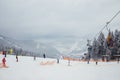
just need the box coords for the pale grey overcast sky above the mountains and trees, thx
[0,0,120,39]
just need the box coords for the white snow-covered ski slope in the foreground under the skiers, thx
[0,55,120,80]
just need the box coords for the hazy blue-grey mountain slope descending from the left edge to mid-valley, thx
[0,35,60,58]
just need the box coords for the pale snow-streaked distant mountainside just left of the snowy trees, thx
[53,38,87,54]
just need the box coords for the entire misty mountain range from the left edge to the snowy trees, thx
[0,35,92,58]
